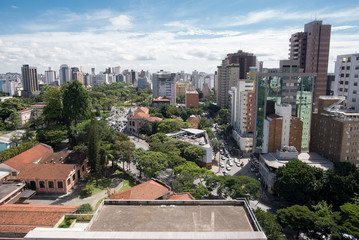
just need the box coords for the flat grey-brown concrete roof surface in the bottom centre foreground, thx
[87,200,256,232]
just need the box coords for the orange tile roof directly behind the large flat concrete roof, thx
[111,180,171,200]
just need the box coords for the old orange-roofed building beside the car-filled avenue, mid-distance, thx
[127,107,162,134]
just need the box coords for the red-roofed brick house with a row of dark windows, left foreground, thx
[17,153,87,193]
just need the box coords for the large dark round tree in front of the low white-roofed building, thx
[274,159,324,206]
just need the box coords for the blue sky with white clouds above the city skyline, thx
[0,0,359,73]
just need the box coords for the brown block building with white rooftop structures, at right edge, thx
[310,96,359,167]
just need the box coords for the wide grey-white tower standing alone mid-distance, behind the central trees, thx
[152,70,176,105]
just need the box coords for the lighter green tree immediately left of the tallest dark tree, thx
[43,88,63,123]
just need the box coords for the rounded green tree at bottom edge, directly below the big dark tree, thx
[277,205,316,239]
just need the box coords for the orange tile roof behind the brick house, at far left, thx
[3,143,53,171]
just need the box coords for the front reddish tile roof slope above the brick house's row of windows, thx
[17,163,75,180]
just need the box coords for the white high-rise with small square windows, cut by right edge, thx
[333,54,359,112]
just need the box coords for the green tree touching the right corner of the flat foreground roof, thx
[254,208,285,240]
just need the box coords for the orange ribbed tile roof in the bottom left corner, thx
[0,204,78,235]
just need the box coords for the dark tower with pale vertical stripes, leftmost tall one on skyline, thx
[21,65,39,97]
